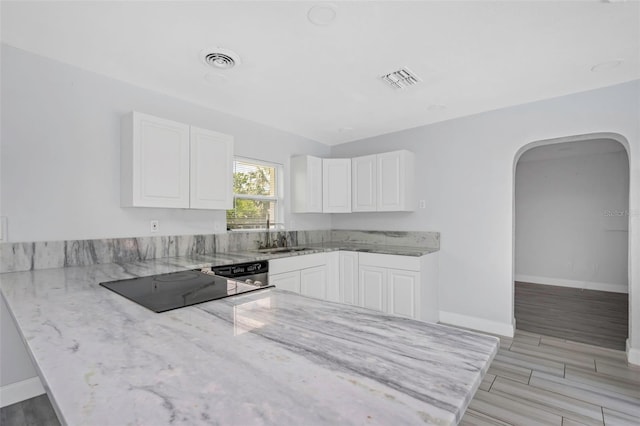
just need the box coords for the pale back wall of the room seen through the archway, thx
[515,145,629,293]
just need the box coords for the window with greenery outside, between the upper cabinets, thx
[227,158,282,229]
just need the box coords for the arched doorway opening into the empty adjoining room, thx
[514,134,630,350]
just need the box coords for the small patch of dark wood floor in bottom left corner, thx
[0,394,60,426]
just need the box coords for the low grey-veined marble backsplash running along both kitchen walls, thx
[0,230,440,273]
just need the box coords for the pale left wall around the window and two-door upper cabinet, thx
[0,45,331,241]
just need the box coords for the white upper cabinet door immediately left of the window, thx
[190,127,233,210]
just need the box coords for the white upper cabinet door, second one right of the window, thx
[322,158,351,213]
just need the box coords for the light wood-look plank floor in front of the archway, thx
[461,330,640,426]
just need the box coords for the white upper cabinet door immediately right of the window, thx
[290,155,322,213]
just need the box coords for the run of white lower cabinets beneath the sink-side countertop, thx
[269,251,438,322]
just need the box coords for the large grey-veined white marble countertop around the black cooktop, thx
[0,254,498,425]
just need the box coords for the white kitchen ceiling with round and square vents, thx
[1,0,640,145]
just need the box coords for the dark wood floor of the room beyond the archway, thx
[515,282,629,350]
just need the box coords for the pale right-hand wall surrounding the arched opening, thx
[332,81,640,363]
